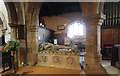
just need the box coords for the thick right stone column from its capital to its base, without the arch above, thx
[84,14,105,73]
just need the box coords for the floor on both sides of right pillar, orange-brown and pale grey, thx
[0,61,120,74]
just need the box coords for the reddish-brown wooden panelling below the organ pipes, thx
[101,29,120,49]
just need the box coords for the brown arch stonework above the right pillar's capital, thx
[80,2,104,17]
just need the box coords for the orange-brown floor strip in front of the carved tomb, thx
[17,66,84,74]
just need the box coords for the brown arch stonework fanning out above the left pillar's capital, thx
[25,2,42,25]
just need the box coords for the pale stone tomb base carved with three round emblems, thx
[37,53,81,70]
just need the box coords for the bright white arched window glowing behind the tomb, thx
[67,21,85,38]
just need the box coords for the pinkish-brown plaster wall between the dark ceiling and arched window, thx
[43,12,82,31]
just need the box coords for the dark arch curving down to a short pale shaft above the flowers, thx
[5,2,18,38]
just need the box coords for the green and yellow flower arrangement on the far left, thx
[3,38,21,52]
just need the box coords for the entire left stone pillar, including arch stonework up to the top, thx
[24,2,42,65]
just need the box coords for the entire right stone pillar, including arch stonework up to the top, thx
[80,2,106,74]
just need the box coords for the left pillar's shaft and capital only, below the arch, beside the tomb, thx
[27,25,38,65]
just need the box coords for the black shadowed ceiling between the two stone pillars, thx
[40,2,81,17]
